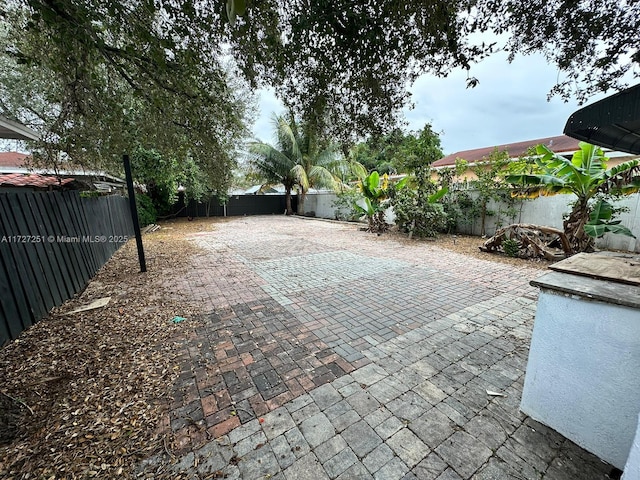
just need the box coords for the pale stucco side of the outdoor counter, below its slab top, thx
[520,289,640,469]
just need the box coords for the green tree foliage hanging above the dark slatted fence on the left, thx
[0,0,251,193]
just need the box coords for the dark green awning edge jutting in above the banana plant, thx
[564,84,640,154]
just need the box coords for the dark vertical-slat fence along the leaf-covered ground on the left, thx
[0,192,133,346]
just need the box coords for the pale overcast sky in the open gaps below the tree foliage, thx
[254,50,604,154]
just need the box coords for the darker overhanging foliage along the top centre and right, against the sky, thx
[228,0,640,139]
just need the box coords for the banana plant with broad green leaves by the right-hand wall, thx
[505,142,640,253]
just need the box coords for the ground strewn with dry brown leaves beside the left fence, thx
[0,222,212,479]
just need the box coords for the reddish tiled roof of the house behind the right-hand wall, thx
[431,135,580,167]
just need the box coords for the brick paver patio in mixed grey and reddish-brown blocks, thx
[139,216,615,480]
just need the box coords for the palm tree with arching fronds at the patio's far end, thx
[249,115,341,215]
